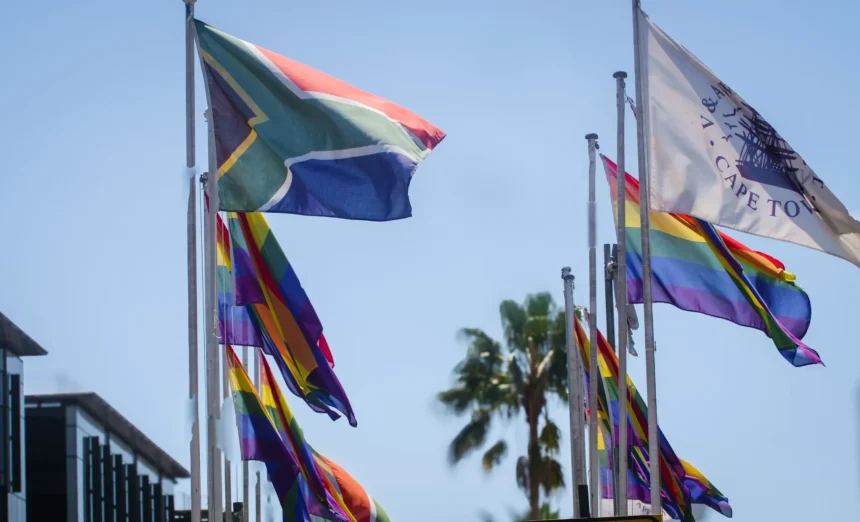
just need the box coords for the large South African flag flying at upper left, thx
[195,20,445,221]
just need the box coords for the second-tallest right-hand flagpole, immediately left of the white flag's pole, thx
[612,71,628,516]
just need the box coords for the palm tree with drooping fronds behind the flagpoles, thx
[438,293,567,520]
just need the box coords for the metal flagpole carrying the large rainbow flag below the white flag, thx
[585,134,600,515]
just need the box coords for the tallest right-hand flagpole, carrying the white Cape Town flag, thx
[633,0,662,513]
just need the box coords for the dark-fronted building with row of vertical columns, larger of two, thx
[25,393,189,522]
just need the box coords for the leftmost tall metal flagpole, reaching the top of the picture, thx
[184,0,202,522]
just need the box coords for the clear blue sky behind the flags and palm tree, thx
[0,0,860,522]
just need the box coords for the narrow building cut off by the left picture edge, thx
[0,312,48,522]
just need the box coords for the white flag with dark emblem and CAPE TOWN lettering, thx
[638,11,860,266]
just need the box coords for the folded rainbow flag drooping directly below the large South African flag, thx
[228,213,357,426]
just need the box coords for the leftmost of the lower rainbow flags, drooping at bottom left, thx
[227,346,349,522]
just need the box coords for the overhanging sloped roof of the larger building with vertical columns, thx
[24,392,190,479]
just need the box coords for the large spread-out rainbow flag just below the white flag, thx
[601,155,821,366]
